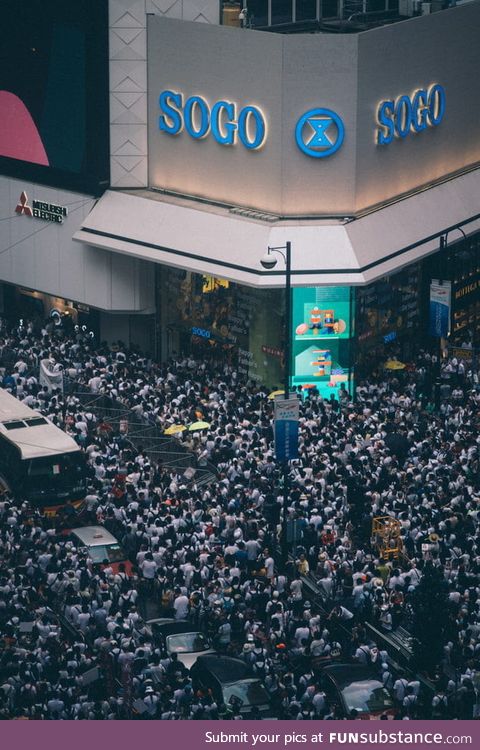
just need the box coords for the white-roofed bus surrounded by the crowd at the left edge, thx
[0,388,87,516]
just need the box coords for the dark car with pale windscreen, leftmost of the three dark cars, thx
[140,617,217,669]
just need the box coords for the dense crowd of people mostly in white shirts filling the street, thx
[0,312,480,719]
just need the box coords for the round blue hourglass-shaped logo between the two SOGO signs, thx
[295,108,345,159]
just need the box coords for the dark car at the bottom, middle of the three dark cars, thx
[190,654,272,718]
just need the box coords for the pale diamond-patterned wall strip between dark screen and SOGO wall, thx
[109,0,220,188]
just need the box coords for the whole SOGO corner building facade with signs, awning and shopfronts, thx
[0,0,480,395]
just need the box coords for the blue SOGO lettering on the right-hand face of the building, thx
[376,83,445,146]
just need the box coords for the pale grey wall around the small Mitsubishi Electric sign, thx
[0,177,154,312]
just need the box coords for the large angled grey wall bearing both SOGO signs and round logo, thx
[148,11,480,218]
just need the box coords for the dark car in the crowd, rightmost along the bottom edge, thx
[319,664,397,719]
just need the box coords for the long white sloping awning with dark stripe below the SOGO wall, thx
[74,169,480,287]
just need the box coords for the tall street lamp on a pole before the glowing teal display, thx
[260,242,292,568]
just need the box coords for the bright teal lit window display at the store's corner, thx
[292,287,352,399]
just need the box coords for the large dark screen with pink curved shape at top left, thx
[0,0,109,193]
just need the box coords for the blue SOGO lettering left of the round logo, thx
[158,89,267,150]
